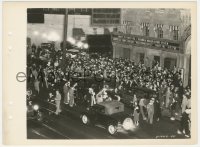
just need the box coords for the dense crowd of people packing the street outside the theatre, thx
[27,43,191,138]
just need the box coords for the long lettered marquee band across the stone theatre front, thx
[112,33,182,53]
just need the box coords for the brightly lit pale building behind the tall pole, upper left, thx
[27,8,121,48]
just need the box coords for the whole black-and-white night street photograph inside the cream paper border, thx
[26,7,192,140]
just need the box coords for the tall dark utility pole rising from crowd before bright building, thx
[62,9,68,66]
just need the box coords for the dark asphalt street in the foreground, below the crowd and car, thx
[27,104,188,139]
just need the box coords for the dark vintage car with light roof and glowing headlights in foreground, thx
[81,101,134,135]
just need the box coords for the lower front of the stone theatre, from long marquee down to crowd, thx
[112,34,191,86]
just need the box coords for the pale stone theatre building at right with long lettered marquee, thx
[112,9,191,86]
